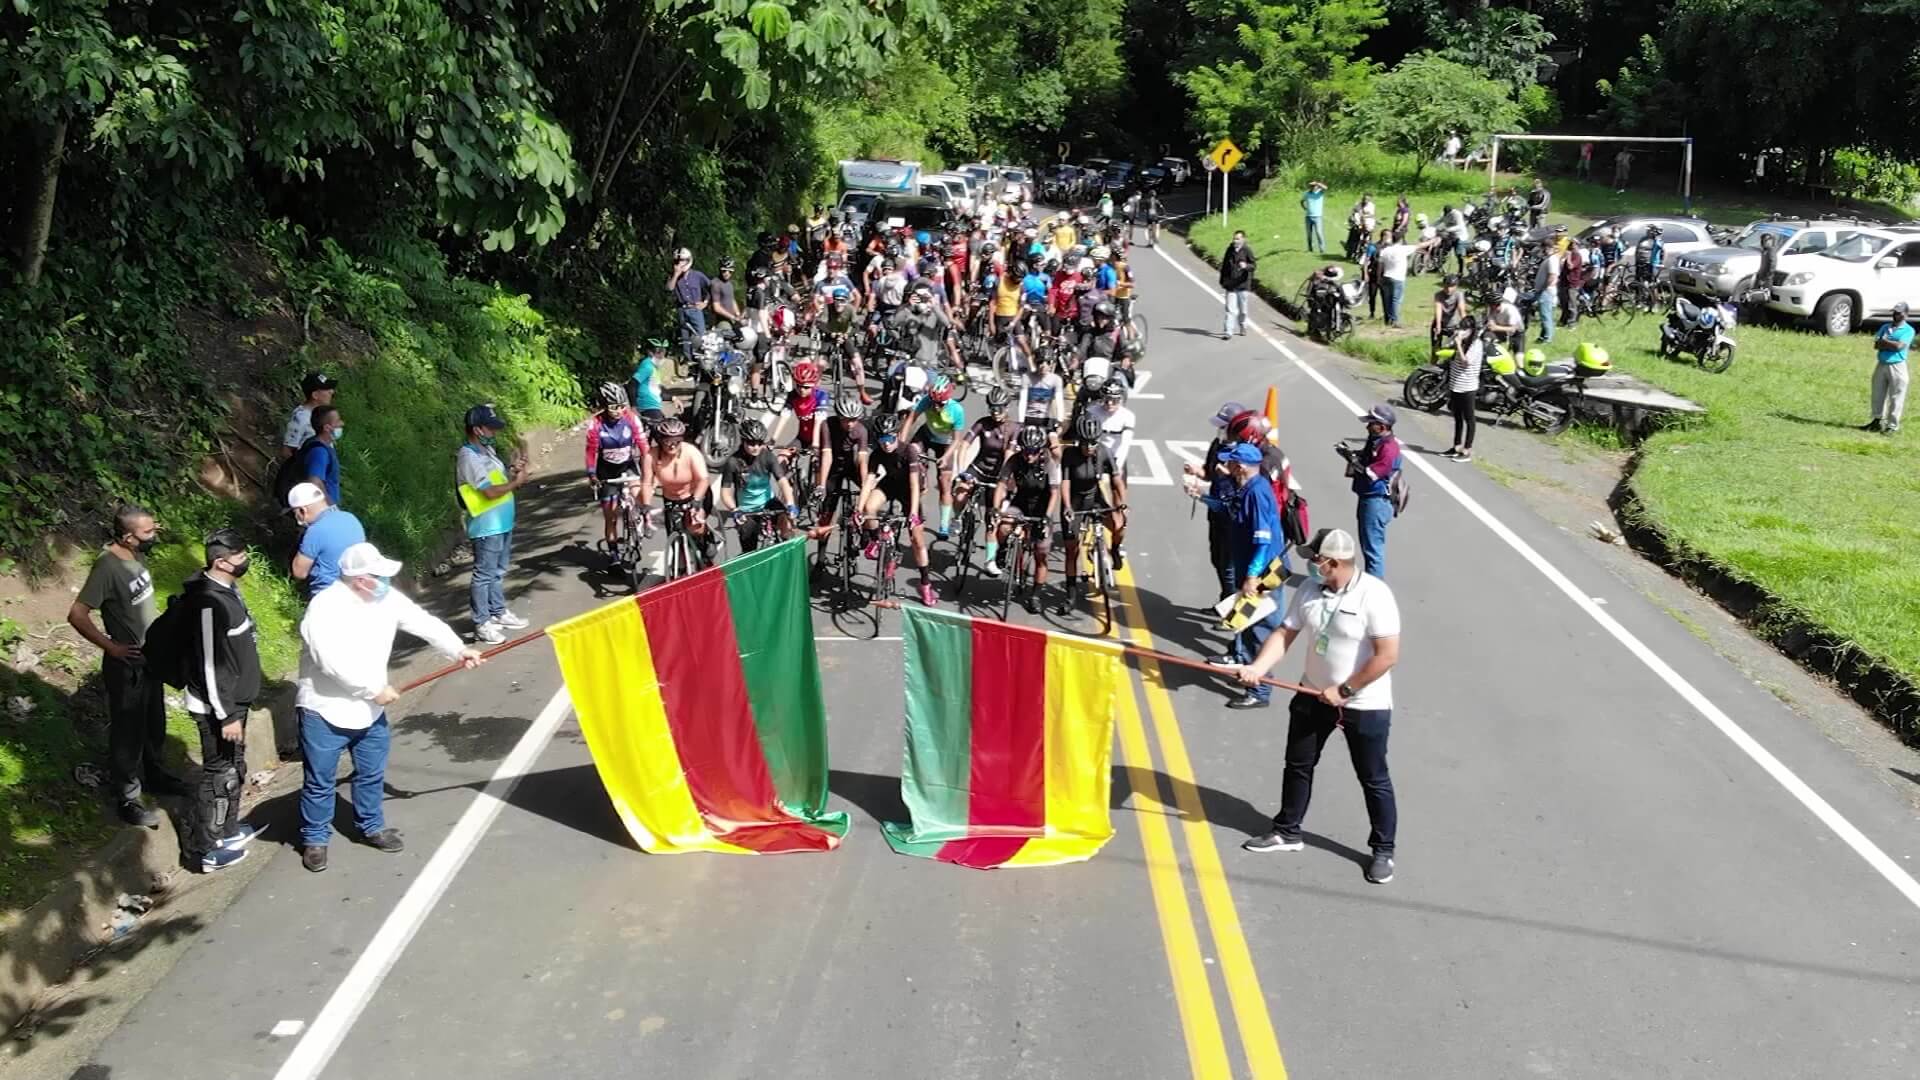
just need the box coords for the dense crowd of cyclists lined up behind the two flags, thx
[586,192,1160,611]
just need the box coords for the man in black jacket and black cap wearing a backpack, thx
[175,528,259,874]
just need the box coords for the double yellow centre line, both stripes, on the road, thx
[1112,557,1286,1080]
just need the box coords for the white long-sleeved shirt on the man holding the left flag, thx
[294,580,467,730]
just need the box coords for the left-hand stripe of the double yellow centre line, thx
[1108,599,1233,1080]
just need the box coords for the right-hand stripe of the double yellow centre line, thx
[1114,567,1286,1080]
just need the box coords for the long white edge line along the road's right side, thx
[1154,237,1920,907]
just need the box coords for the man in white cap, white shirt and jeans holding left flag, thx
[294,538,482,872]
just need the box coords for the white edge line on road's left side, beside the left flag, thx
[275,686,572,1080]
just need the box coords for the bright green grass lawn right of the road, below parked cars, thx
[1190,154,1920,699]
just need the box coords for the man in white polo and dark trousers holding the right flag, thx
[1235,528,1400,886]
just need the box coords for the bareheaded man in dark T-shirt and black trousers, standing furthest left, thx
[67,505,190,828]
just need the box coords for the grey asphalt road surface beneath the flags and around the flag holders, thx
[60,212,1920,1080]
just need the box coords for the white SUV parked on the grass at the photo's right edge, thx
[1766,225,1920,336]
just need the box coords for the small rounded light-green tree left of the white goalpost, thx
[1350,52,1521,177]
